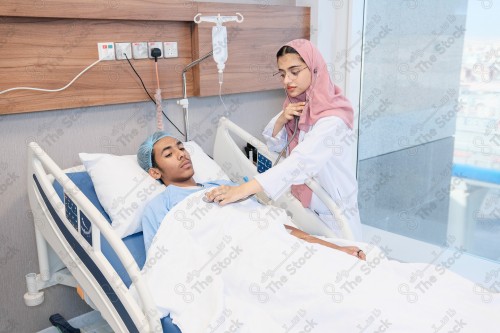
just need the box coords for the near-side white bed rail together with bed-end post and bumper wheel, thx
[25,142,162,332]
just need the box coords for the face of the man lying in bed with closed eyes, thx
[149,137,194,186]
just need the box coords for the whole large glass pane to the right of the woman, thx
[358,0,500,260]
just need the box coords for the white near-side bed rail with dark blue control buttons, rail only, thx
[28,142,162,332]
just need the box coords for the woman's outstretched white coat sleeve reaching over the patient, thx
[255,117,347,200]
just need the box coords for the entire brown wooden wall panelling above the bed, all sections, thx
[0,0,310,115]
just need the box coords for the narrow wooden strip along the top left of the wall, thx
[0,0,197,21]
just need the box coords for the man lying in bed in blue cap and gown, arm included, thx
[137,132,366,260]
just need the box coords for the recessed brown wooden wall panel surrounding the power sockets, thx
[0,18,193,114]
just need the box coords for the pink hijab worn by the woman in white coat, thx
[283,39,354,208]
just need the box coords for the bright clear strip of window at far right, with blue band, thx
[448,1,500,261]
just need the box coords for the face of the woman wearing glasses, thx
[277,53,311,97]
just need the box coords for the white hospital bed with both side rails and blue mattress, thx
[24,118,352,332]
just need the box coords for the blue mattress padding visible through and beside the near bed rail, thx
[54,171,181,333]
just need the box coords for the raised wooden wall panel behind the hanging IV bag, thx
[194,3,310,96]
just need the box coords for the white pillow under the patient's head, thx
[79,142,229,238]
